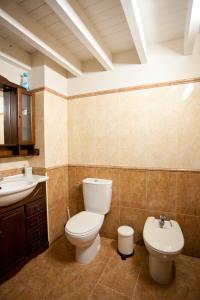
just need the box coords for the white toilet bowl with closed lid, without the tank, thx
[65,211,104,264]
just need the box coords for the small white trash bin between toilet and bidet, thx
[117,226,134,259]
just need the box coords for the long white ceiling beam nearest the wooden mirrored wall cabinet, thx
[0,2,82,76]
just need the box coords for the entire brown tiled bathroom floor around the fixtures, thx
[0,236,200,300]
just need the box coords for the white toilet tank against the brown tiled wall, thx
[82,178,112,215]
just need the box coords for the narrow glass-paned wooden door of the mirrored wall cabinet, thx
[18,89,35,145]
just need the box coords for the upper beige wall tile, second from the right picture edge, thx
[145,87,177,168]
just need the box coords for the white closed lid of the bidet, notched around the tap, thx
[143,217,184,254]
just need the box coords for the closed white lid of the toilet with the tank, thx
[65,211,104,235]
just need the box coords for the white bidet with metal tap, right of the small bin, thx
[143,217,184,284]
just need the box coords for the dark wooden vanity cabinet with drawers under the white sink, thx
[0,182,49,283]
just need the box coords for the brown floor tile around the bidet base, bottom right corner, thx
[134,255,200,300]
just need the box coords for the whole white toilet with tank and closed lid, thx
[65,178,112,264]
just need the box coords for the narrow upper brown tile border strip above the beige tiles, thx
[31,77,200,100]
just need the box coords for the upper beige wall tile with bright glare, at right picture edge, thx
[177,83,200,170]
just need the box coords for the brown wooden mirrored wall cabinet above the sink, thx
[0,76,39,157]
